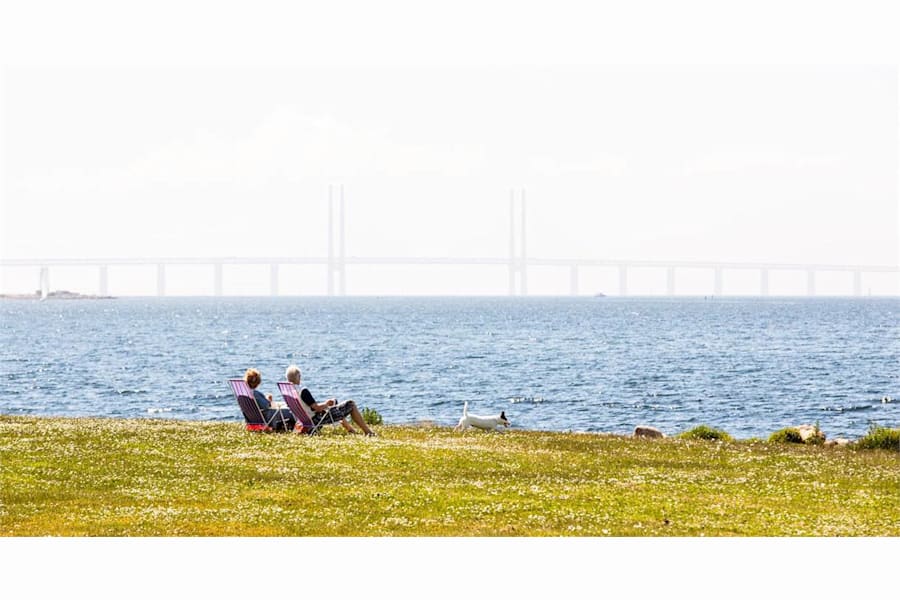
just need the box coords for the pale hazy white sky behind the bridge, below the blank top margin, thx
[0,4,900,295]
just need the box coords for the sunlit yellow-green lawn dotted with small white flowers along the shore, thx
[0,416,900,536]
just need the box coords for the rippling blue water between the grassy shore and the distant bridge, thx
[0,298,900,438]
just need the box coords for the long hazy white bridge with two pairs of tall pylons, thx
[0,186,900,296]
